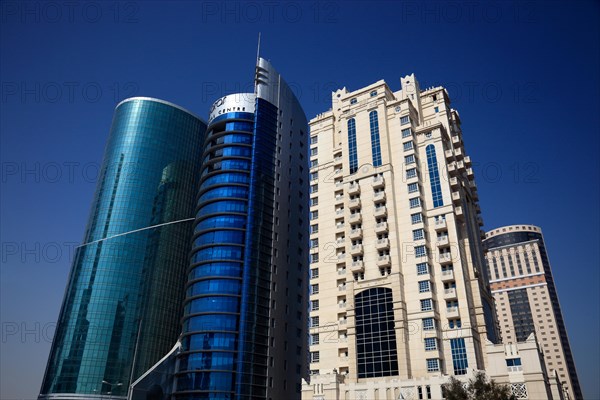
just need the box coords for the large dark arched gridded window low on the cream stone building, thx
[354,288,398,378]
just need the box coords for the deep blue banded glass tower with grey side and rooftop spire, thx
[174,58,308,400]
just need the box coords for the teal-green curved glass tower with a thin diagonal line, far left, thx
[40,98,206,399]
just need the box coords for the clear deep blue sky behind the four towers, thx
[0,0,600,399]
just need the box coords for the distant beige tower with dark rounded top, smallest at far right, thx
[484,225,583,400]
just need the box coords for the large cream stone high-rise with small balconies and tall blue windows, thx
[310,75,497,388]
